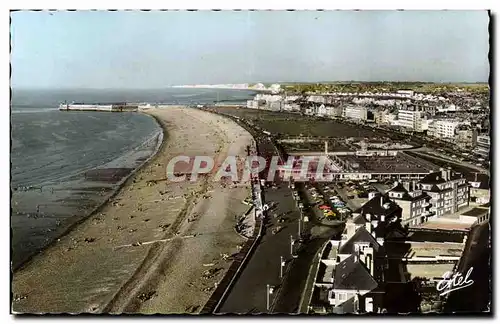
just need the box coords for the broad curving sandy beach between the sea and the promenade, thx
[12,107,252,313]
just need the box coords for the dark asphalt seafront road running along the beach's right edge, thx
[213,110,342,314]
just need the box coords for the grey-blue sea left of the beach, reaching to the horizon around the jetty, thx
[10,88,255,270]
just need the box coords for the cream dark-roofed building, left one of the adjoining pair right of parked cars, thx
[387,181,431,226]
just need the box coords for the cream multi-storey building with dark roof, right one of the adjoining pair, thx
[418,168,469,218]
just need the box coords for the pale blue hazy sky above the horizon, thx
[10,11,489,89]
